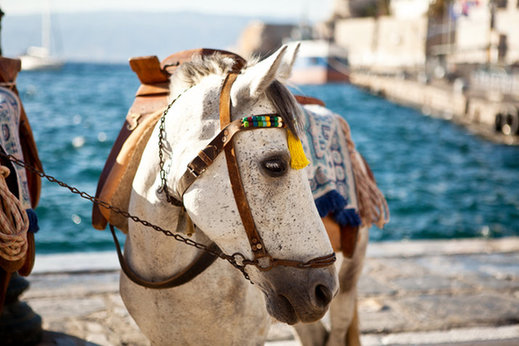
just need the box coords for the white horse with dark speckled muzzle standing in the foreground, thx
[120,47,338,345]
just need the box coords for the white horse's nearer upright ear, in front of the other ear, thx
[233,46,287,101]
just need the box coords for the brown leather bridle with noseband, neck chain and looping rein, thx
[110,72,336,288]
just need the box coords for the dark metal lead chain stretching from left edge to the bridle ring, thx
[0,152,257,283]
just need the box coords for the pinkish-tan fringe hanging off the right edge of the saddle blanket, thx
[339,118,389,228]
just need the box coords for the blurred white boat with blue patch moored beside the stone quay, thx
[290,40,350,84]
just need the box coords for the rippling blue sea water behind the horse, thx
[17,63,519,254]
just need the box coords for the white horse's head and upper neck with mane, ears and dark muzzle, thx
[132,45,338,324]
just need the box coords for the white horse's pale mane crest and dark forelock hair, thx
[169,53,302,136]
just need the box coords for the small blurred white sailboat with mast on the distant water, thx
[18,2,64,71]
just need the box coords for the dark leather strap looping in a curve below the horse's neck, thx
[109,224,221,289]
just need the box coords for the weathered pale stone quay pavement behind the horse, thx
[22,238,519,346]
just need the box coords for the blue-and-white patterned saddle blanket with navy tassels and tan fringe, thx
[301,104,389,258]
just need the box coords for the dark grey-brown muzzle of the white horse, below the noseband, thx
[253,265,339,324]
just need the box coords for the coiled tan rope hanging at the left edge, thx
[0,166,29,262]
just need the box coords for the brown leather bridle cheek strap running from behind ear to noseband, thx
[220,73,269,259]
